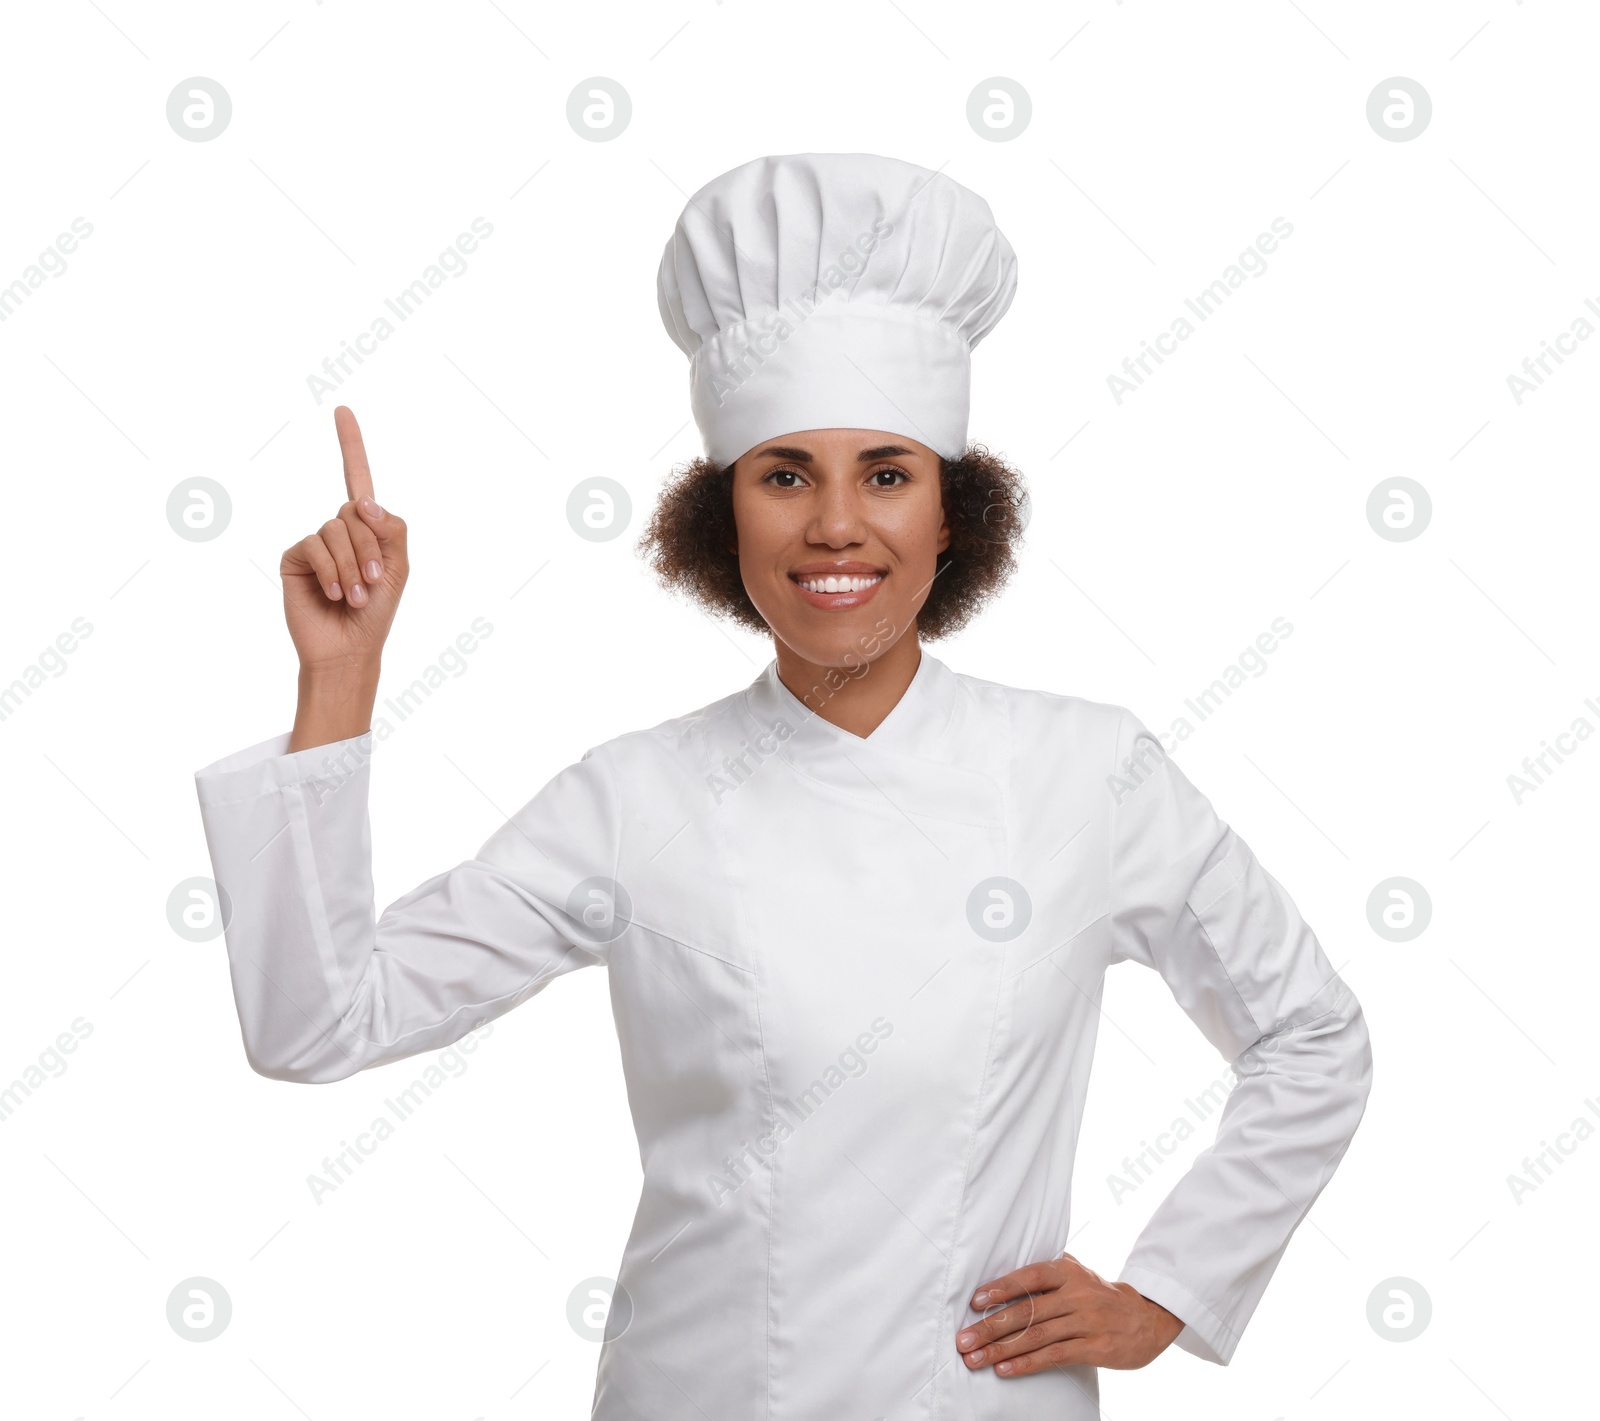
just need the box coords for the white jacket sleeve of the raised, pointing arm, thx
[195,731,619,1083]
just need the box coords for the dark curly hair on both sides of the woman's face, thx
[638,445,1029,640]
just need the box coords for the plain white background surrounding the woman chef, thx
[0,0,1600,1421]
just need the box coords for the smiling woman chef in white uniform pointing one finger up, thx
[197,154,1371,1421]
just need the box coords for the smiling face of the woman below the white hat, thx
[733,429,950,666]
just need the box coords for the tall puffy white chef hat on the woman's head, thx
[656,154,1016,466]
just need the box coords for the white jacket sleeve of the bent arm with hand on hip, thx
[1109,712,1373,1365]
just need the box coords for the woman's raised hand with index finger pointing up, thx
[278,405,411,680]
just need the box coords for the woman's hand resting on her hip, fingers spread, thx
[955,1253,1184,1376]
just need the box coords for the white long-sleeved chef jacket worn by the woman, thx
[195,651,1371,1421]
